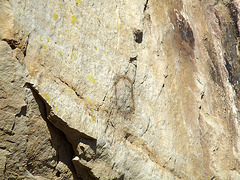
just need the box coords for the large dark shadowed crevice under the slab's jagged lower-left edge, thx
[25,83,96,179]
